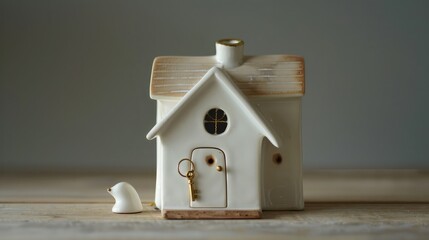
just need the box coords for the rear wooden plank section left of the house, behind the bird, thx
[0,173,155,203]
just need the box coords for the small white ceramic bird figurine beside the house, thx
[107,182,143,213]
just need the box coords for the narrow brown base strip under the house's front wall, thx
[162,210,262,219]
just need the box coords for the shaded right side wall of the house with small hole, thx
[252,97,304,210]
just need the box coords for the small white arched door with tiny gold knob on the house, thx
[191,148,227,208]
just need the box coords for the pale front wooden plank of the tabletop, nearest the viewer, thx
[0,203,429,240]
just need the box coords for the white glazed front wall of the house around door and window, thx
[160,84,263,210]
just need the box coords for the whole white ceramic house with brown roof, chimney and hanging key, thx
[147,39,304,219]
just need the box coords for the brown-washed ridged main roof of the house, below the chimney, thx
[150,55,304,99]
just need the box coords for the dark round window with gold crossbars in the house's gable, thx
[204,108,228,135]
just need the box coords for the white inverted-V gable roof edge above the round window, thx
[146,67,279,147]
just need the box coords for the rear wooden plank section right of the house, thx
[303,169,429,203]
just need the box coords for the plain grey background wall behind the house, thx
[0,0,429,171]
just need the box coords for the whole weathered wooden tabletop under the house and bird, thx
[0,171,429,240]
